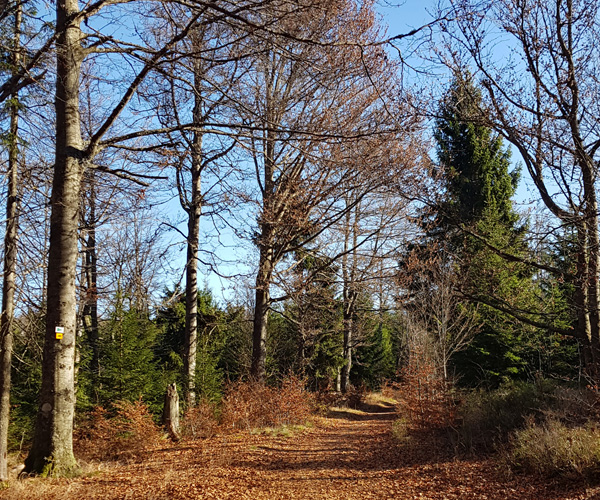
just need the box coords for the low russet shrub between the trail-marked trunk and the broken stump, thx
[75,400,162,460]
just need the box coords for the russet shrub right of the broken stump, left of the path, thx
[221,377,315,430]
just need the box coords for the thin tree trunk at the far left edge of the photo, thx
[0,3,22,481]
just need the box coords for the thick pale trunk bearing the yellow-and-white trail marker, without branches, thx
[24,0,84,476]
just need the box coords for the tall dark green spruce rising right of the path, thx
[429,74,534,385]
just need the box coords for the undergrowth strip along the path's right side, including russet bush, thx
[383,364,600,482]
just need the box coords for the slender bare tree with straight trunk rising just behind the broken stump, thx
[148,7,237,406]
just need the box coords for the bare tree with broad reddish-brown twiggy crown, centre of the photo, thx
[230,1,418,379]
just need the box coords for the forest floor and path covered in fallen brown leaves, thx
[0,402,600,500]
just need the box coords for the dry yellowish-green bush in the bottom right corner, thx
[507,418,600,479]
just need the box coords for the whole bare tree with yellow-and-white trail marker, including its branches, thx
[22,0,308,475]
